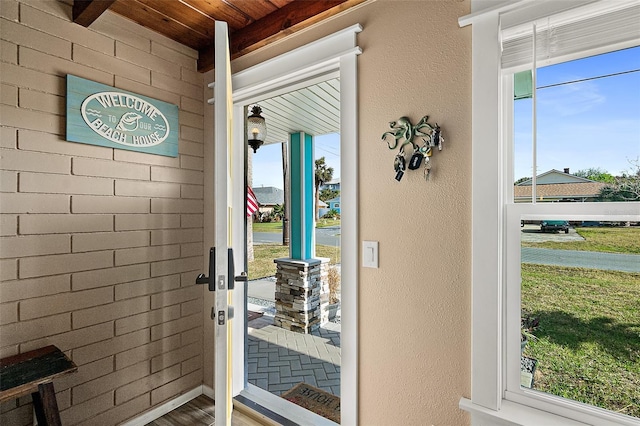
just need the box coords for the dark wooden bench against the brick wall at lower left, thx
[0,345,78,426]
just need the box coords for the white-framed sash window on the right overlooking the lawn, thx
[460,1,640,424]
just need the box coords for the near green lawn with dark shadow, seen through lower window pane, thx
[522,264,640,417]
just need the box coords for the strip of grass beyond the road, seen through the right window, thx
[522,226,640,254]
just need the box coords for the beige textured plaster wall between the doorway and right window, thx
[212,0,471,426]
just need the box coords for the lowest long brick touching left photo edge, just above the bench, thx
[0,314,71,346]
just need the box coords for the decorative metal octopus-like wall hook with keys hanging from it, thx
[382,115,444,182]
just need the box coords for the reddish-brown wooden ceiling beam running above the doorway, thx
[198,0,368,72]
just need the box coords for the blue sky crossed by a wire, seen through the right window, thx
[514,47,640,180]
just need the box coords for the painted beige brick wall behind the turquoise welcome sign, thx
[0,0,204,425]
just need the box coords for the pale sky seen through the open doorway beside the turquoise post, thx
[253,131,340,189]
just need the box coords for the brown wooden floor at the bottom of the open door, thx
[146,395,260,426]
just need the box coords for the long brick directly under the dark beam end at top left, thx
[20,5,114,54]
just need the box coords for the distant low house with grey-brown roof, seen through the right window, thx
[513,169,606,203]
